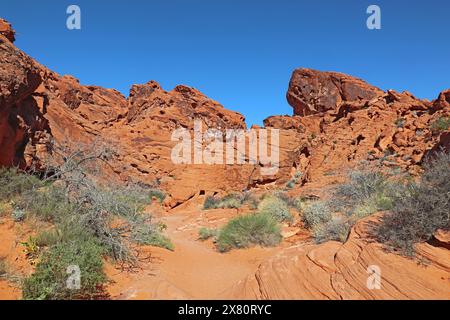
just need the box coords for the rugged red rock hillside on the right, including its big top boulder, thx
[280,69,450,186]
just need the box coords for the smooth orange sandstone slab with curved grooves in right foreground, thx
[224,217,450,300]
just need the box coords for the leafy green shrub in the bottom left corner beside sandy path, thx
[22,234,107,300]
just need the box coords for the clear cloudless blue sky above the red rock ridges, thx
[0,0,450,124]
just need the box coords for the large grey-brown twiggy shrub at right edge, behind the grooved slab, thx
[376,152,450,255]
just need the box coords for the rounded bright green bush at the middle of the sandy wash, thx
[216,213,281,252]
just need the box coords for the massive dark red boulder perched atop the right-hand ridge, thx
[287,69,383,116]
